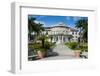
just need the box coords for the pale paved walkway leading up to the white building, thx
[41,44,79,60]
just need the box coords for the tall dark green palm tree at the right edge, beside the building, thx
[75,19,88,42]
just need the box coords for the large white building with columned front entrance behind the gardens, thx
[42,22,79,44]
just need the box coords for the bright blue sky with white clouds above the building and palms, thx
[28,15,88,27]
